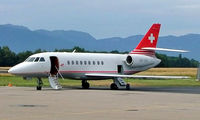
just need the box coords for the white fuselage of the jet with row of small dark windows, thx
[9,52,160,80]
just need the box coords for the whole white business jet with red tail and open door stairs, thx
[8,24,187,90]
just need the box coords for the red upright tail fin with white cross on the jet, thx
[130,24,161,56]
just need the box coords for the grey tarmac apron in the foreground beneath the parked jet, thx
[0,87,200,120]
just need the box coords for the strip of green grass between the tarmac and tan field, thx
[0,76,200,87]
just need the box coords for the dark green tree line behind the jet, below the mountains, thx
[0,46,199,67]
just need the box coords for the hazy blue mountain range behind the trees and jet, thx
[0,24,200,60]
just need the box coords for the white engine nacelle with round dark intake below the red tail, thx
[125,54,160,67]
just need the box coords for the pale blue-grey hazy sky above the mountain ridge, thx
[0,0,200,38]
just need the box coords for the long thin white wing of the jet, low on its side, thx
[85,73,190,79]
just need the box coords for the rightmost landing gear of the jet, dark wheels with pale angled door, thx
[110,78,130,90]
